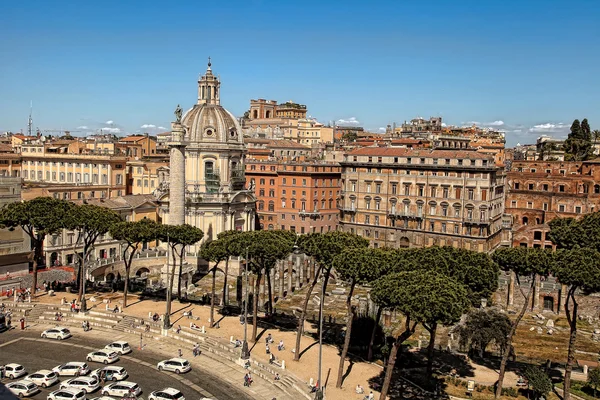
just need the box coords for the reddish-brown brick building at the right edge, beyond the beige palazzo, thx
[505,160,600,248]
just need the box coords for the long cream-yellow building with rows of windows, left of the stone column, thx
[21,144,127,199]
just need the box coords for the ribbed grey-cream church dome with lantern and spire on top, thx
[181,59,244,145]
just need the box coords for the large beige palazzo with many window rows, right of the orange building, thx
[340,147,505,252]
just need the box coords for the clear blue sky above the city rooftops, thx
[0,0,600,145]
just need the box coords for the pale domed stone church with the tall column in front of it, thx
[155,61,256,245]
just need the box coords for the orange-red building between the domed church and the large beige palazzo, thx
[246,159,341,234]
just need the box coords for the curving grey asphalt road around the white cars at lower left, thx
[0,330,251,400]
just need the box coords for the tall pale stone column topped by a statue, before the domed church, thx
[169,122,185,225]
